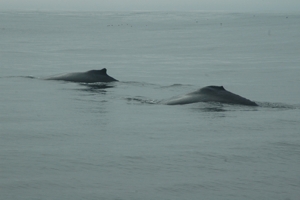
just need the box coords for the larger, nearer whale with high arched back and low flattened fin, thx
[163,86,258,106]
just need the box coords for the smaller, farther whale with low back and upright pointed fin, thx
[44,68,118,83]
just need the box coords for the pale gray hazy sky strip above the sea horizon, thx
[0,0,300,12]
